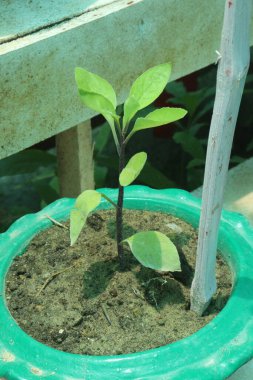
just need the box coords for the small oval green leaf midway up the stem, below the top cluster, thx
[119,152,147,186]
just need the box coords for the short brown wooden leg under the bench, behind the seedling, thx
[56,120,94,197]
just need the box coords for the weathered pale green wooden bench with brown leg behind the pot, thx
[0,0,253,196]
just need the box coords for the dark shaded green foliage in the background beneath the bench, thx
[0,49,253,232]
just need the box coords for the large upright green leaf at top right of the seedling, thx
[123,63,171,127]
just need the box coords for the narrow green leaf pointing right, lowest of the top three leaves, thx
[129,107,187,136]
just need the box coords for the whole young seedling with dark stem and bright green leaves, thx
[70,63,187,271]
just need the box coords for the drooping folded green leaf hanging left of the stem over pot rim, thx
[70,190,101,246]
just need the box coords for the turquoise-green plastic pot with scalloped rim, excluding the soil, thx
[0,186,253,380]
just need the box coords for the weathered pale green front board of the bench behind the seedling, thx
[0,0,253,158]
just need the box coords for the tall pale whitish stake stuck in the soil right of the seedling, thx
[191,0,252,315]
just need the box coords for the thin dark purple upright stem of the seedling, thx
[116,132,126,271]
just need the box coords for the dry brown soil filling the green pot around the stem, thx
[6,210,231,355]
